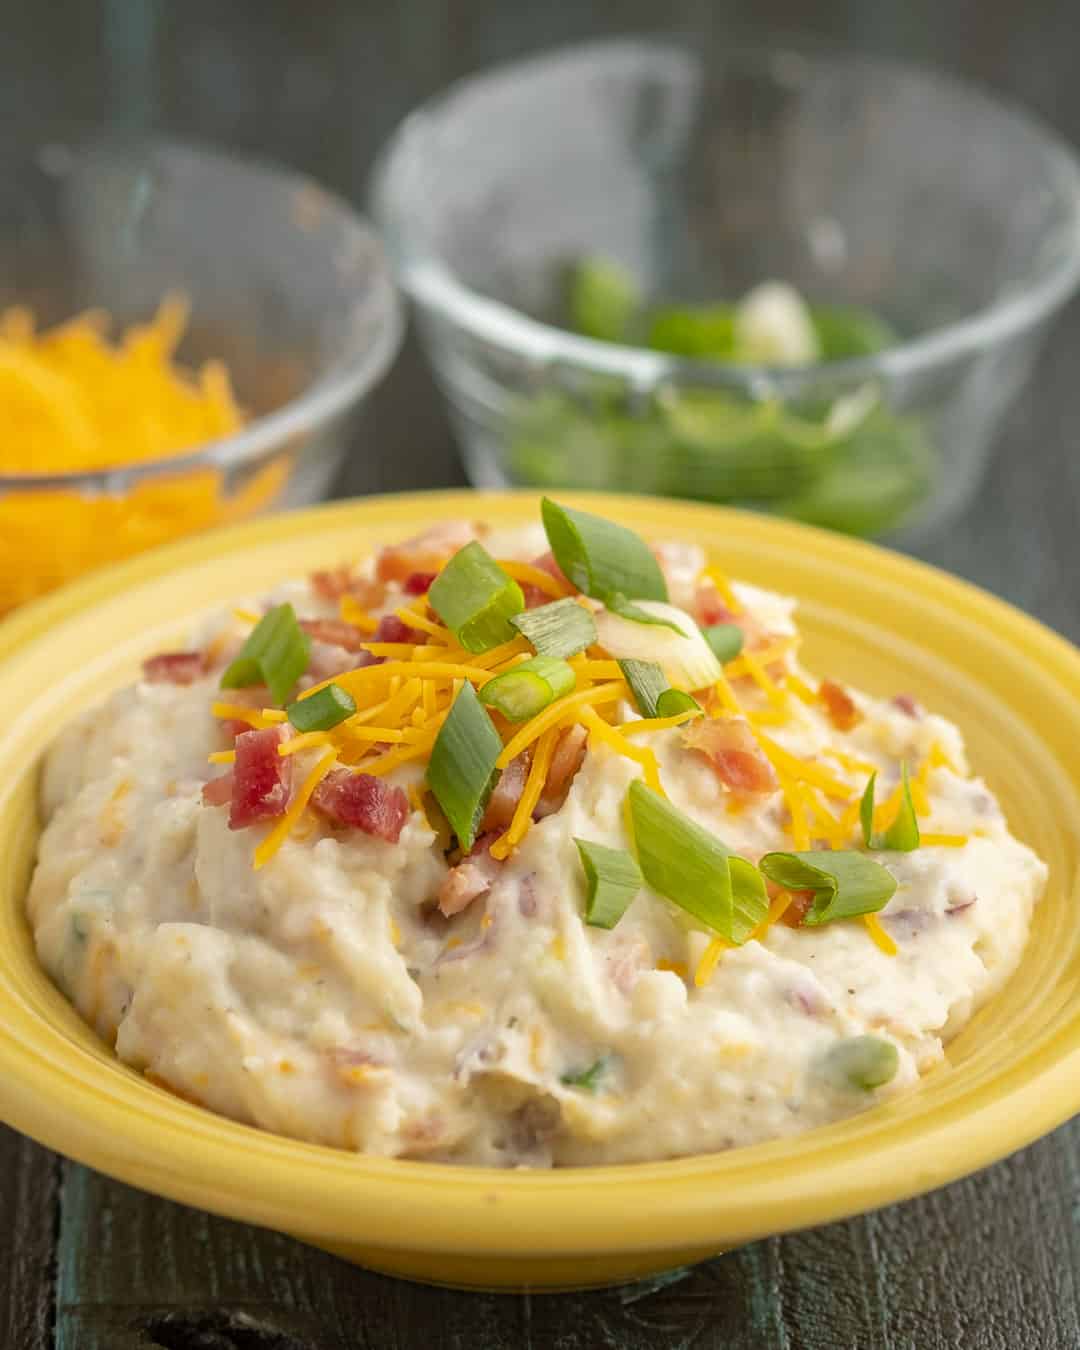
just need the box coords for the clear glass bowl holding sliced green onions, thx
[373,41,1080,535]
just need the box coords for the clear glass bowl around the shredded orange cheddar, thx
[0,134,402,613]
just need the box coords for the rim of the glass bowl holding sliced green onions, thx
[367,34,1080,397]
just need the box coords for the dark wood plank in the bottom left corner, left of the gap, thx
[0,1126,61,1350]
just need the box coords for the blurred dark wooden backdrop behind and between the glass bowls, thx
[0,0,1080,628]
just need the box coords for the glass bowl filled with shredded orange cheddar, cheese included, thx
[0,135,402,616]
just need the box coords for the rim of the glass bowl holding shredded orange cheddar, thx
[0,123,405,497]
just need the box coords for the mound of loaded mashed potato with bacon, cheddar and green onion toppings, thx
[28,502,1046,1166]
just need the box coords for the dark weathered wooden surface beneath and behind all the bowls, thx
[0,0,1080,1350]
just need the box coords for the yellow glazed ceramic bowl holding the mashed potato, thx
[0,493,1080,1289]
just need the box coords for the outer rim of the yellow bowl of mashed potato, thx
[0,491,1080,1257]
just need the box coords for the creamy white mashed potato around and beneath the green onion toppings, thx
[28,510,1046,1166]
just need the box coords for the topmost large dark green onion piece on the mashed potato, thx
[540,497,667,605]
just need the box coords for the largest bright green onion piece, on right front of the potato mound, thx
[629,780,768,945]
